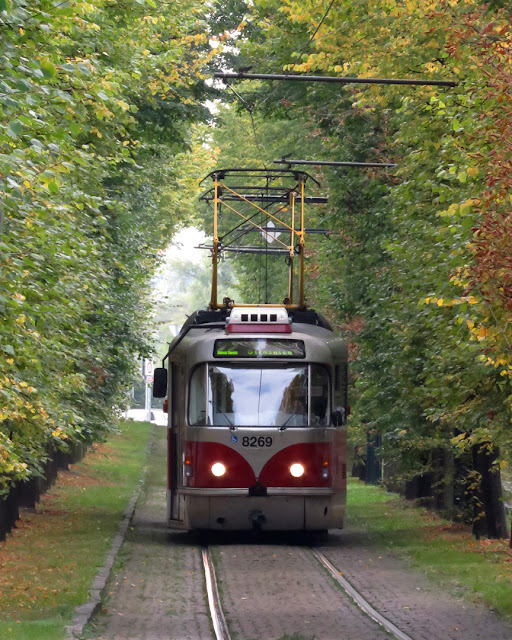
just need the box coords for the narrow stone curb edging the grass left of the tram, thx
[66,424,155,640]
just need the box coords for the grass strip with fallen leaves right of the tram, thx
[347,479,512,620]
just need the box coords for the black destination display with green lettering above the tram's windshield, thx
[213,338,306,359]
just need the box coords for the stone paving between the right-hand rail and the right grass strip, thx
[317,529,512,640]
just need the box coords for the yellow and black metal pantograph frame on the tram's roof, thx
[200,168,322,310]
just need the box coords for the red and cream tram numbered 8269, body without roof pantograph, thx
[153,306,348,531]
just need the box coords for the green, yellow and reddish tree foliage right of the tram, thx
[210,0,512,528]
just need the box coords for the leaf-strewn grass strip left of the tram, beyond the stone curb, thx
[0,422,151,640]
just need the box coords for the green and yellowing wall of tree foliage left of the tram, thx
[0,0,209,495]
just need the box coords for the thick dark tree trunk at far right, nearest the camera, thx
[473,444,507,539]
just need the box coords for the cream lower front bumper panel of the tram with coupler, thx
[185,495,344,531]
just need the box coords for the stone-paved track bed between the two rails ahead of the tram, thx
[212,538,390,640]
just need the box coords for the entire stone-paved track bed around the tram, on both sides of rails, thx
[85,427,512,640]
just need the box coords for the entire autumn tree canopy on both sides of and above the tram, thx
[4,0,512,536]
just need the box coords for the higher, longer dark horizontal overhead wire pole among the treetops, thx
[213,71,458,87]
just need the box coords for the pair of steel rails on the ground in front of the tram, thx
[201,545,413,640]
